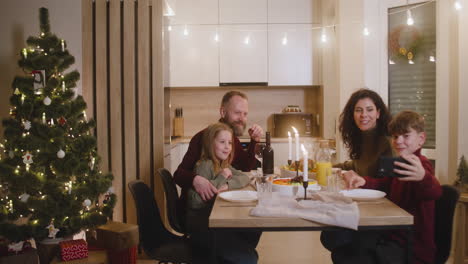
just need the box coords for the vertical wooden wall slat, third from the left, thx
[109,0,124,221]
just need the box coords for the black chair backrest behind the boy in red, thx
[434,185,460,264]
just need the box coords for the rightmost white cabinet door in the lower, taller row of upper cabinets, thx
[268,24,315,85]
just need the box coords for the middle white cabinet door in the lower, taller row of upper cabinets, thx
[219,24,268,83]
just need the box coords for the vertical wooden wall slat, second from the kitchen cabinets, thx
[137,0,152,189]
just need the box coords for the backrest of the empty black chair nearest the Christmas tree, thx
[128,180,173,251]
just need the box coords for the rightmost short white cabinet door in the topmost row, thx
[268,0,312,23]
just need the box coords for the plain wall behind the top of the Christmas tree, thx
[0,0,82,138]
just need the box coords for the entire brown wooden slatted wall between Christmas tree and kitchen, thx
[82,0,165,223]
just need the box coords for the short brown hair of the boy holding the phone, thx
[388,110,424,135]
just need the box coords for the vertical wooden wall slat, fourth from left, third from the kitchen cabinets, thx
[121,0,137,224]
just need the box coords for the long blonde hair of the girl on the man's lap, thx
[200,123,234,174]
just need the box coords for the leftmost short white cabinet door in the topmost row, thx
[165,0,219,25]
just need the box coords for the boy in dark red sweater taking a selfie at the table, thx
[332,111,442,263]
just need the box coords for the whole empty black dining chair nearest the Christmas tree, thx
[128,180,192,264]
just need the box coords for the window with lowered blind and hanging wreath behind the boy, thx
[388,1,437,149]
